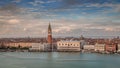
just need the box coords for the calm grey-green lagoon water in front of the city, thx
[0,52,120,68]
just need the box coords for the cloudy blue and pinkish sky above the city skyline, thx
[0,0,120,38]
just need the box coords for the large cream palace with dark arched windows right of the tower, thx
[57,41,80,51]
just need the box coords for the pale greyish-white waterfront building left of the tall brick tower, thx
[29,43,44,51]
